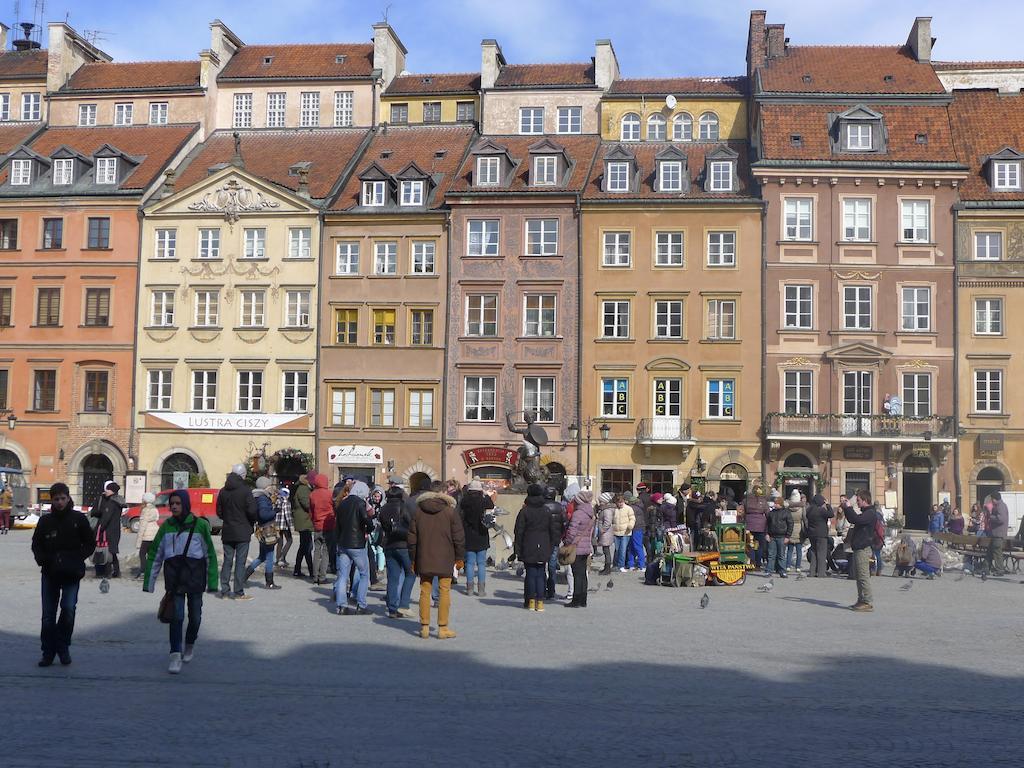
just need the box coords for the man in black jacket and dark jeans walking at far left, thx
[32,482,96,667]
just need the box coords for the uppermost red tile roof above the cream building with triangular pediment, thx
[217,43,374,80]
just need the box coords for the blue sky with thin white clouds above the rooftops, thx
[14,0,1024,77]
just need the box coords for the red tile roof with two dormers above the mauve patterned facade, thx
[452,135,601,195]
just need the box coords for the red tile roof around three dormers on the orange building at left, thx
[30,123,199,189]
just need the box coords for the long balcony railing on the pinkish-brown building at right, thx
[765,414,956,440]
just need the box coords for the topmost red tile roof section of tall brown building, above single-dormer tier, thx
[759,45,945,94]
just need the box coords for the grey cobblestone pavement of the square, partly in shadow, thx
[0,531,1024,768]
